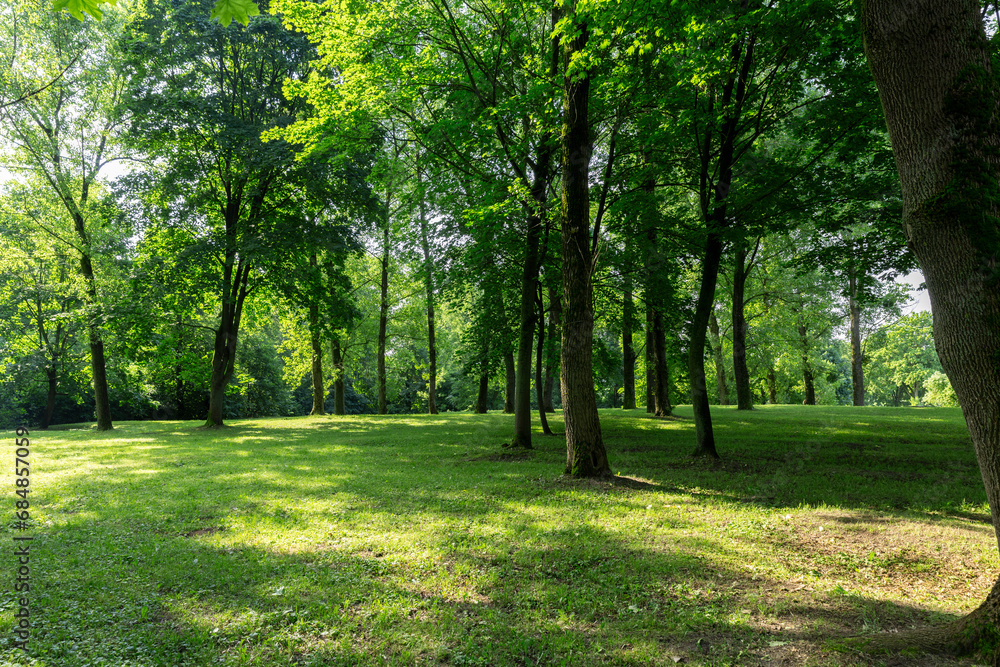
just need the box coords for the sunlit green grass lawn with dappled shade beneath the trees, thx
[0,406,1000,667]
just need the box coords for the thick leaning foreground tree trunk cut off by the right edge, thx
[858,0,1000,652]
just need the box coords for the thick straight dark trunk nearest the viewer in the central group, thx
[560,2,611,477]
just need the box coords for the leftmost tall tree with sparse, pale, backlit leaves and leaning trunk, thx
[2,0,125,431]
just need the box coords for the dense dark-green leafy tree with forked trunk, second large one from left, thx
[123,1,336,426]
